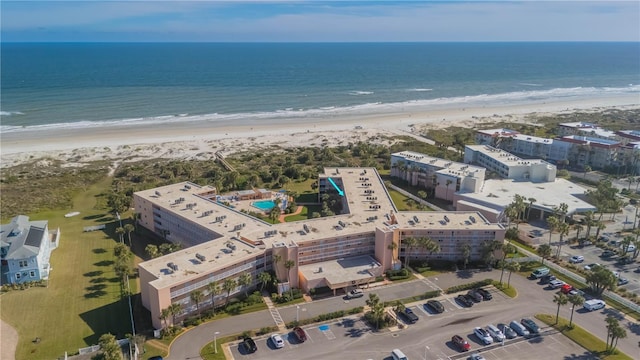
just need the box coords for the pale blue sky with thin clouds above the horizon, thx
[0,0,640,42]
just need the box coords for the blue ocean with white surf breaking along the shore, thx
[0,43,640,132]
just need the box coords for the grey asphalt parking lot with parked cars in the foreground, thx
[230,290,590,360]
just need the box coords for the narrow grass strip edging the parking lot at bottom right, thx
[536,314,632,360]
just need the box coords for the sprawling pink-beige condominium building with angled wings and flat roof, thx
[134,168,505,328]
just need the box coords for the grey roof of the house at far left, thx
[0,215,47,260]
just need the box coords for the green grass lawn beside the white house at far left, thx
[0,178,137,360]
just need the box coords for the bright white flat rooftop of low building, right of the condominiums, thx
[460,178,596,214]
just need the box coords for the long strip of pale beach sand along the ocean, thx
[0,95,640,168]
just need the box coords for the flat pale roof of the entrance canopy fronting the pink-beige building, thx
[299,255,382,285]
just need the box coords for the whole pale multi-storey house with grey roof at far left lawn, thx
[0,215,60,284]
